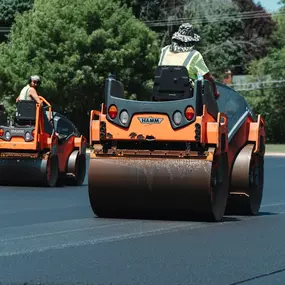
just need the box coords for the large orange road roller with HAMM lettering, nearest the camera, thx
[88,66,265,221]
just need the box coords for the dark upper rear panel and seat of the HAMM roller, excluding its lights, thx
[105,66,218,129]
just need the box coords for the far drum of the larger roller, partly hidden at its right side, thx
[226,144,264,215]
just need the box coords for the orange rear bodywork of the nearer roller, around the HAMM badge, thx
[89,100,265,169]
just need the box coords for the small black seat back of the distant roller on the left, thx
[16,100,36,125]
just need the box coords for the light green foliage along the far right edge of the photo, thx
[244,8,285,143]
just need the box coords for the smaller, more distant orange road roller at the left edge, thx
[0,97,87,187]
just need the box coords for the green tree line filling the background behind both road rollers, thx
[0,0,285,142]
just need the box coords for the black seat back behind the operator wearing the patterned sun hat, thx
[152,66,193,101]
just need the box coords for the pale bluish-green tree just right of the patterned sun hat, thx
[179,0,243,79]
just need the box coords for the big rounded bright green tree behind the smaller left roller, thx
[0,0,159,135]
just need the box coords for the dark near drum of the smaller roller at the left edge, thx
[0,155,59,187]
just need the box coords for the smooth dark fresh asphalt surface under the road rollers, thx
[0,157,285,285]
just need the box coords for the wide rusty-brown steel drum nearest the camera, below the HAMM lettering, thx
[88,152,228,221]
